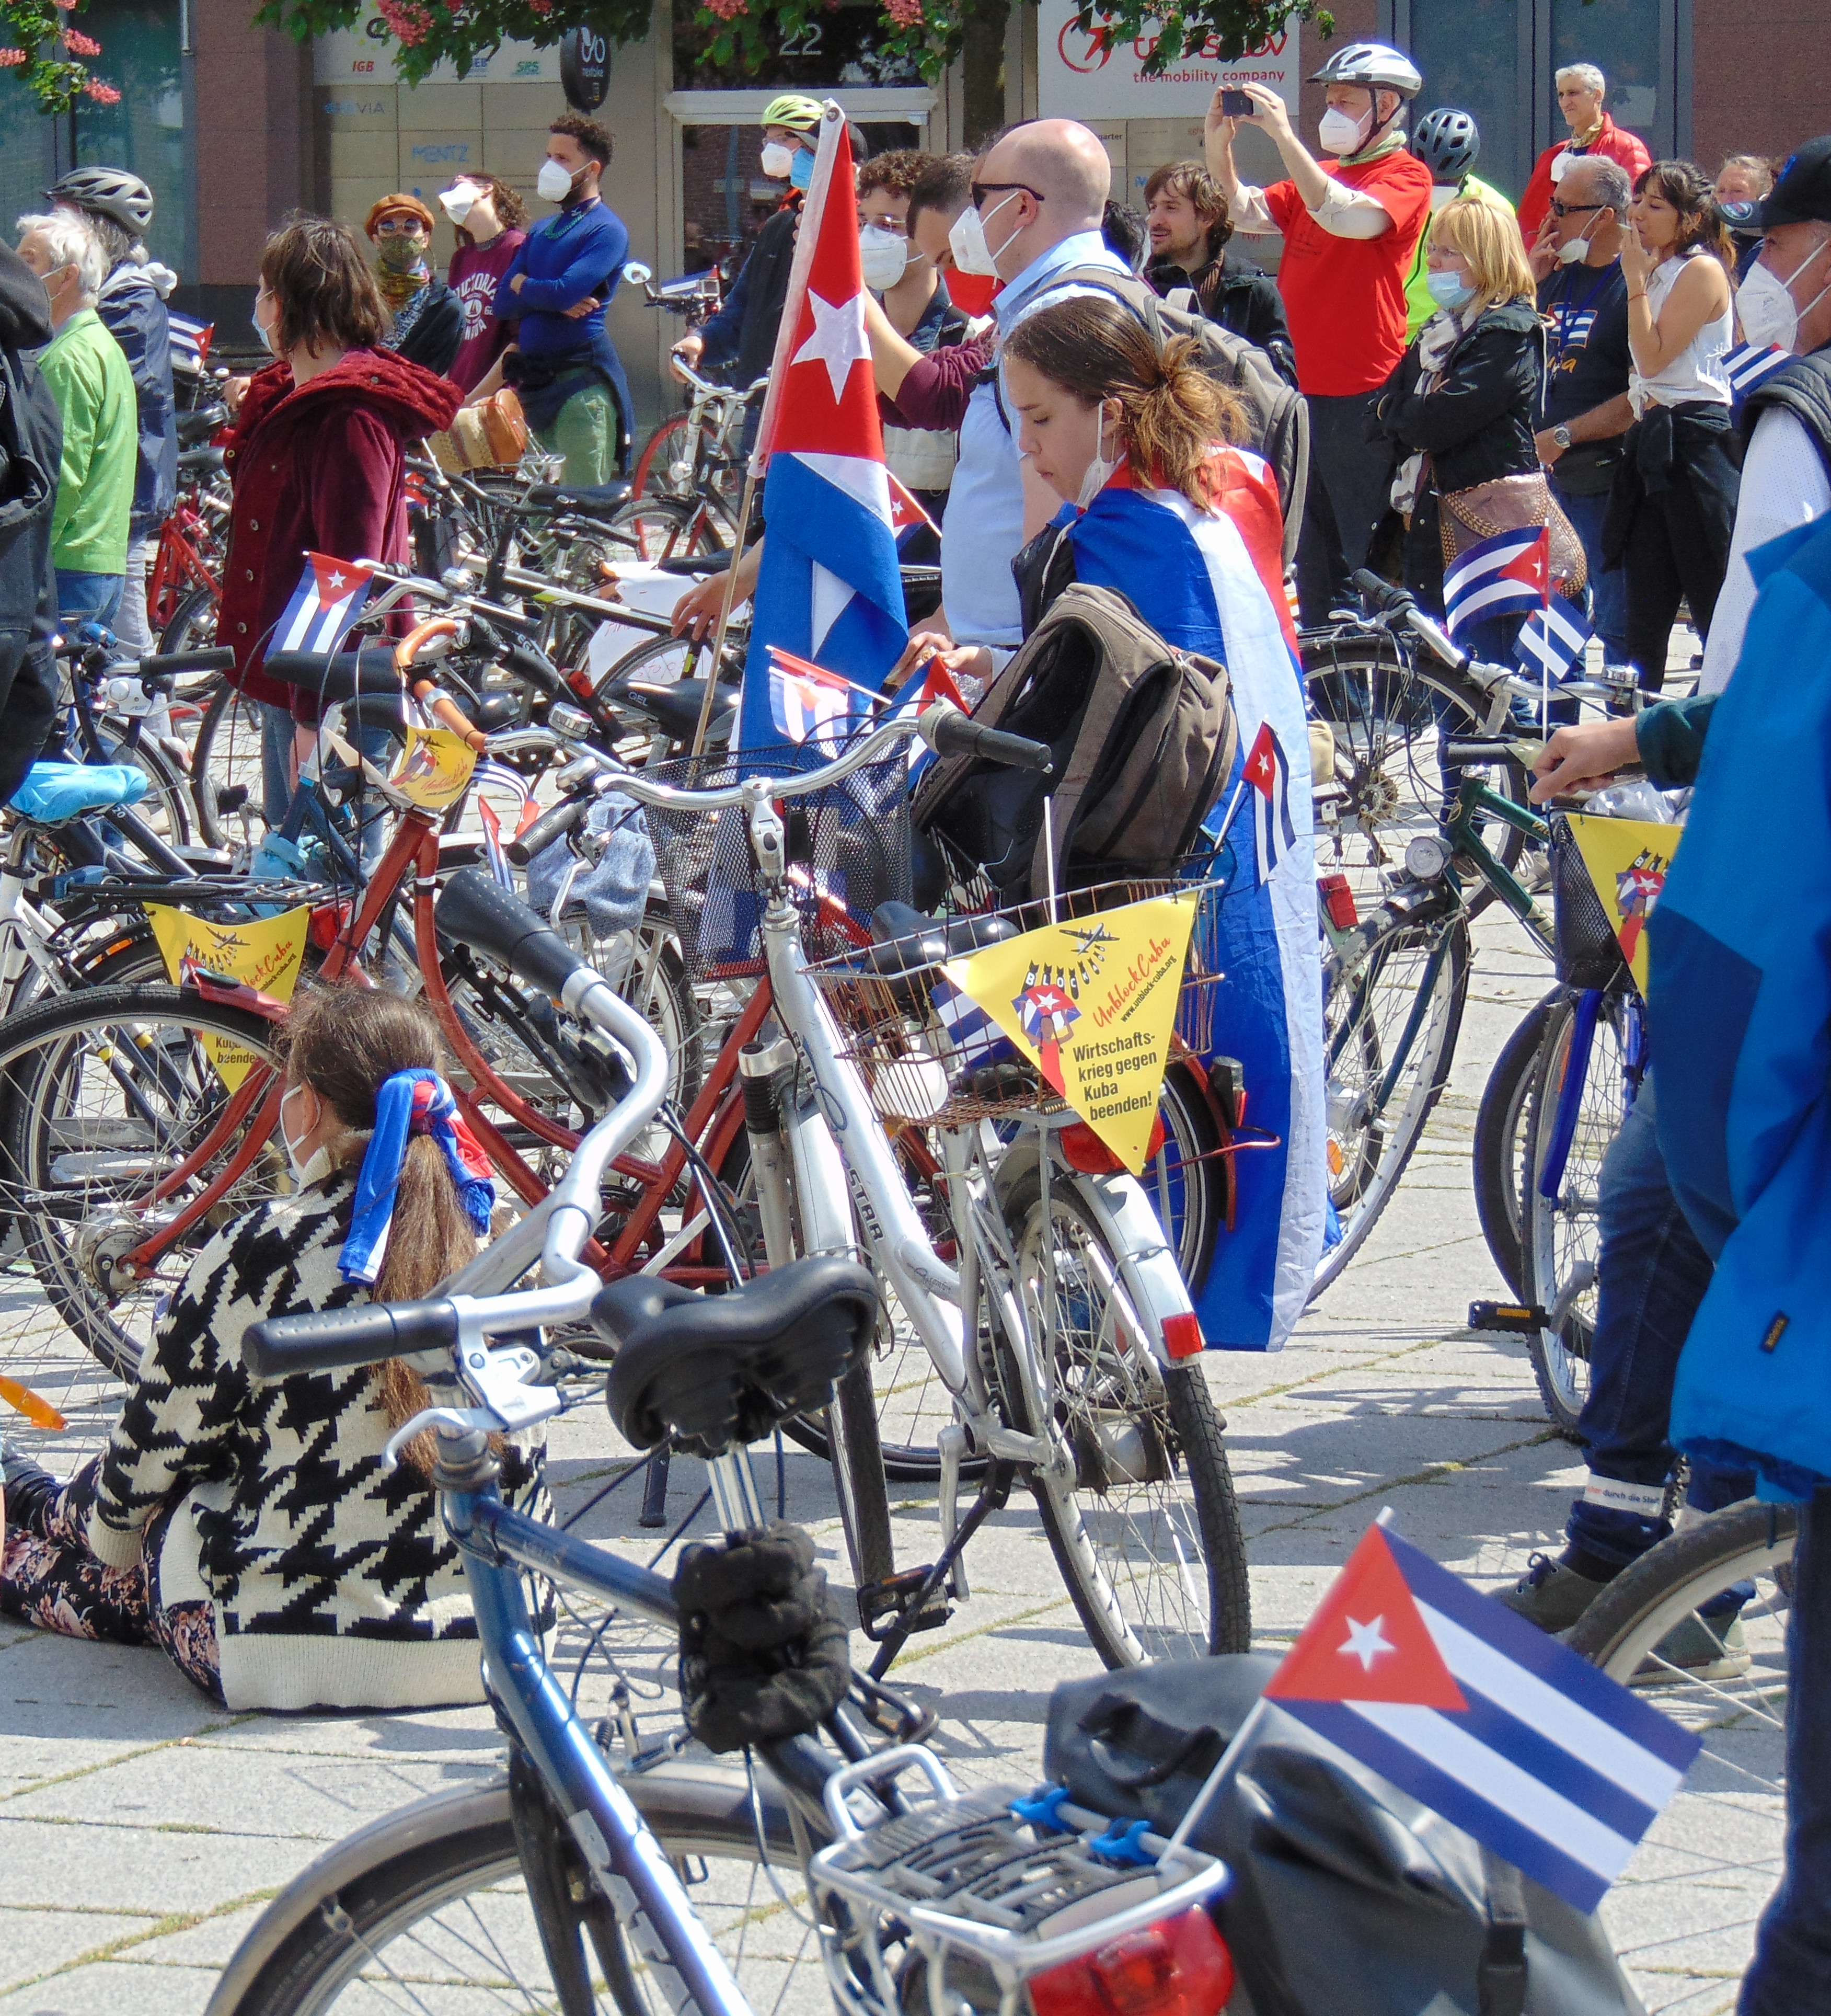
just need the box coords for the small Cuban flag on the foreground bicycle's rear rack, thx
[1264,1526,1700,1911]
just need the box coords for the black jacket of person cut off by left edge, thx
[0,244,64,805]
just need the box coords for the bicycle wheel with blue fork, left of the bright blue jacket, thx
[1521,988,1627,1441]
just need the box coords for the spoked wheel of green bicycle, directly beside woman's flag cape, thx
[1311,917,1470,1298]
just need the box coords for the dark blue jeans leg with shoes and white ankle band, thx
[1565,1072,1750,1572]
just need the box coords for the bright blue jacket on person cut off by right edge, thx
[1648,518,1831,1498]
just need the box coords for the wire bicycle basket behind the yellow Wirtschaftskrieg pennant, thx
[809,881,1226,1127]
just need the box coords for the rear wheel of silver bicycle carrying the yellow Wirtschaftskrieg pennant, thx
[998,1169,1250,1667]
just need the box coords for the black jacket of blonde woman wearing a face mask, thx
[1375,301,1545,496]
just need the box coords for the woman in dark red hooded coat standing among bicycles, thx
[216,217,462,839]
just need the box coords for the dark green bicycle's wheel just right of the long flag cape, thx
[1311,915,1472,1300]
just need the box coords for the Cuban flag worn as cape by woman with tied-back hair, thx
[1057,448,1327,1351]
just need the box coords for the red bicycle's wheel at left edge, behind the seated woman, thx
[0,986,291,1413]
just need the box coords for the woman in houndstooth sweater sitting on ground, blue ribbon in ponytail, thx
[0,988,538,1710]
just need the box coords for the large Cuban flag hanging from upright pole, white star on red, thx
[740,103,909,748]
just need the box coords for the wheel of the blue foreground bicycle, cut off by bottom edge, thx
[210,1762,807,2016]
